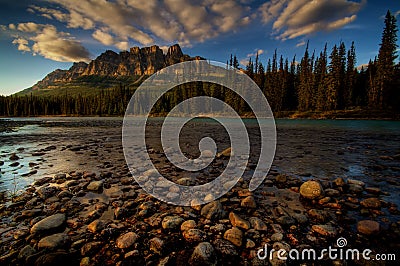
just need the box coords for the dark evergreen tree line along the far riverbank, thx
[0,11,400,116]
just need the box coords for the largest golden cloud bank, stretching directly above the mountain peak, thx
[30,0,254,48]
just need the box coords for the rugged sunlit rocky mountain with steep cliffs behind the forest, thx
[18,44,203,95]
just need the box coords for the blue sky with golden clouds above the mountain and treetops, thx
[0,0,400,95]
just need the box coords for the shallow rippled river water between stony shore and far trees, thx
[0,117,400,209]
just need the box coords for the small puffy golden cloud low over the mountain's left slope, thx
[8,22,90,62]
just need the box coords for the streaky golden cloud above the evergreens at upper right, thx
[259,0,366,40]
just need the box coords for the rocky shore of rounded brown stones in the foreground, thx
[0,167,400,265]
